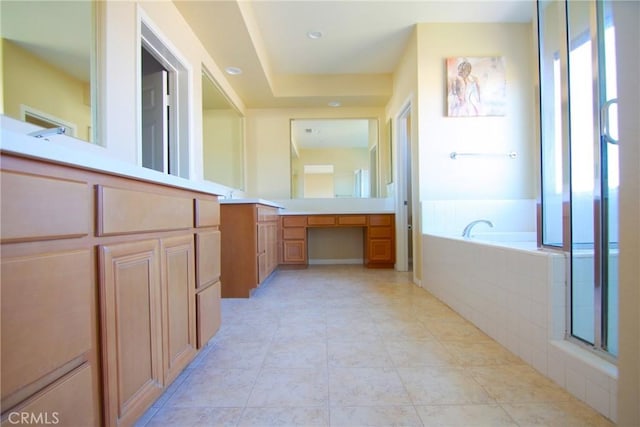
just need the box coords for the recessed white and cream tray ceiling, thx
[173,0,533,108]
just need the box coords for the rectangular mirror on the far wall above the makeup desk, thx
[291,119,379,199]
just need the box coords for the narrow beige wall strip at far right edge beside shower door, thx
[613,1,640,426]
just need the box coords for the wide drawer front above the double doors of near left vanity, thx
[98,186,193,236]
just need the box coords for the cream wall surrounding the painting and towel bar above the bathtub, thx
[418,24,538,201]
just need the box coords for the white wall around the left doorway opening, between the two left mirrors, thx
[98,1,245,193]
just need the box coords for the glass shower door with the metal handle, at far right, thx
[567,1,618,355]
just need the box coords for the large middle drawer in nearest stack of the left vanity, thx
[1,250,95,399]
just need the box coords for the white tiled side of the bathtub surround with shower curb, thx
[422,235,617,421]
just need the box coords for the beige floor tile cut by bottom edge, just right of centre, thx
[331,406,422,427]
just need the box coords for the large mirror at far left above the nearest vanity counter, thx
[0,0,95,145]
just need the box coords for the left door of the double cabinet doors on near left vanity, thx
[100,240,163,425]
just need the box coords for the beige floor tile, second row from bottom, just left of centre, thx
[247,368,329,407]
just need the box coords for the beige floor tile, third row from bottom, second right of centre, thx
[385,340,457,368]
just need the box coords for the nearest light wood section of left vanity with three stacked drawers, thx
[0,166,101,426]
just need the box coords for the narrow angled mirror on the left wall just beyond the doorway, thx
[202,72,244,190]
